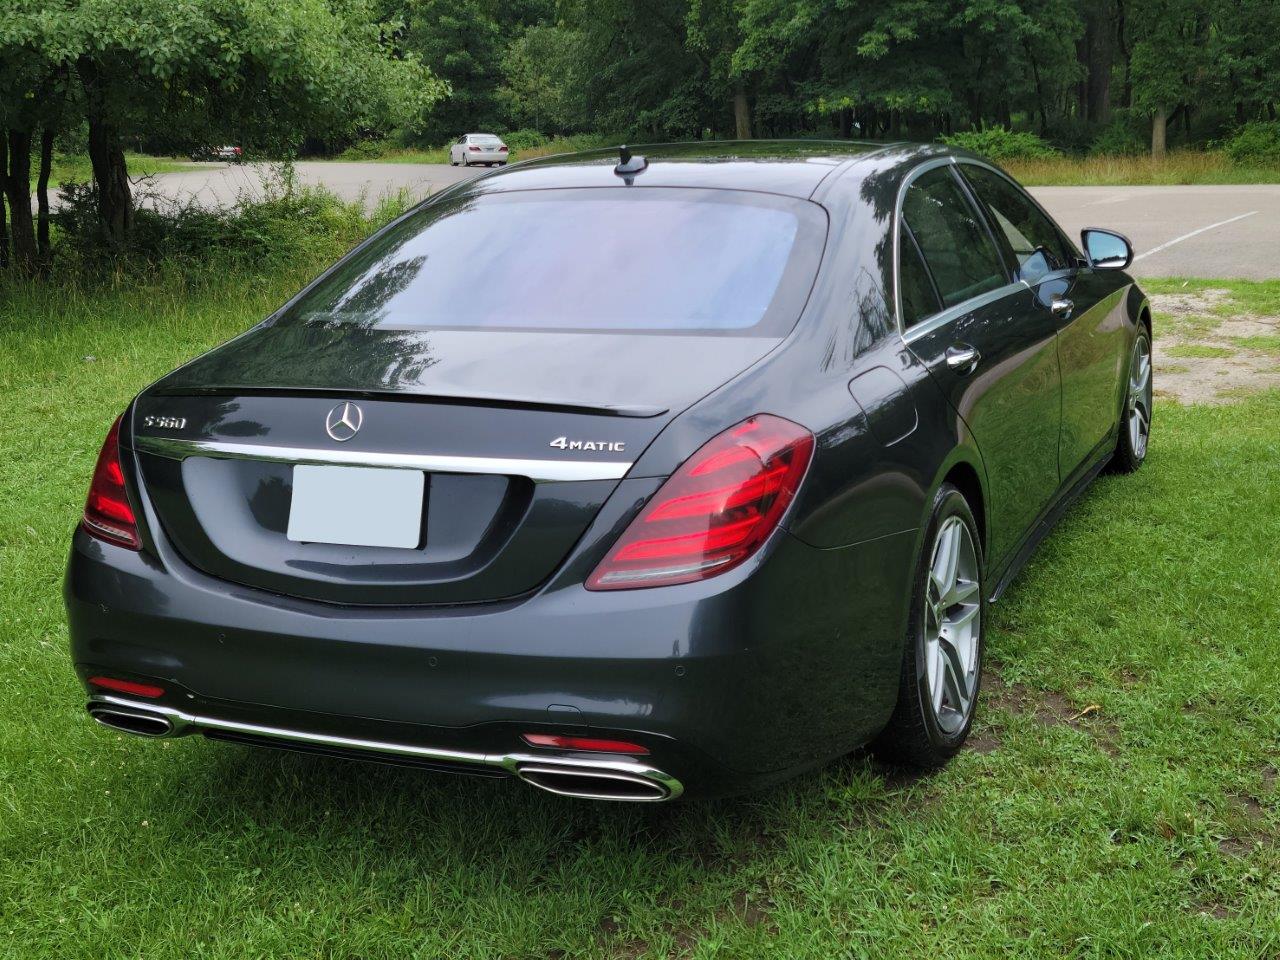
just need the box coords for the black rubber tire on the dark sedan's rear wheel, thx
[872,484,987,769]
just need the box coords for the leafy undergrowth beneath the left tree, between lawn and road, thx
[52,166,411,275]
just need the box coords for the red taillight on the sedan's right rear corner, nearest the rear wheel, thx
[586,413,813,590]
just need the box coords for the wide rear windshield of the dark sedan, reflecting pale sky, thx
[282,187,826,335]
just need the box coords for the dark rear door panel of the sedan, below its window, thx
[910,284,1061,570]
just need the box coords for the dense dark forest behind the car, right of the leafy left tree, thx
[384,0,1280,154]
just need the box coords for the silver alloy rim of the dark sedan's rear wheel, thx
[923,517,982,733]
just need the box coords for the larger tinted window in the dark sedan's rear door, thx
[902,166,1007,307]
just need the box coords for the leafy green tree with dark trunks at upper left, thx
[0,0,444,260]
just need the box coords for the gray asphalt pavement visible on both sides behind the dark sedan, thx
[140,163,1280,279]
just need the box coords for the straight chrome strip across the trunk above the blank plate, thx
[133,435,631,483]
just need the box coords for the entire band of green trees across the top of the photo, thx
[0,0,1280,269]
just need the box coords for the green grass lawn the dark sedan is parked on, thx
[0,270,1280,960]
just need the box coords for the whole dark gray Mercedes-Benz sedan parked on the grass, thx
[65,142,1152,800]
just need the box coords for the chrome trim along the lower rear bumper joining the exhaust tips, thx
[88,694,685,803]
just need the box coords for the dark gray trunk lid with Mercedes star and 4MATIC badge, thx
[137,326,776,604]
